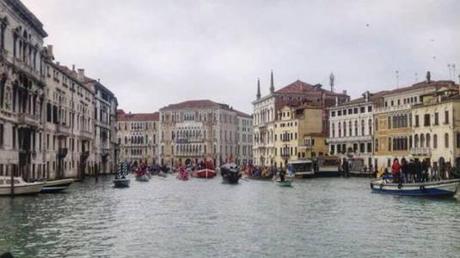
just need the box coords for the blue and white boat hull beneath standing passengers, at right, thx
[370,179,460,197]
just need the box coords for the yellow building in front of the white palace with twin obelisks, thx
[274,106,328,167]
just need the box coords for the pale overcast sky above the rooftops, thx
[23,0,460,113]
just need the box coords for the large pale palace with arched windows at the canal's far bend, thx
[159,100,251,166]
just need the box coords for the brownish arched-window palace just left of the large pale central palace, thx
[117,110,159,164]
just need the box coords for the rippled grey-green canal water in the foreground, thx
[0,177,460,257]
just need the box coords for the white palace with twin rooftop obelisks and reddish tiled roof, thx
[252,73,350,166]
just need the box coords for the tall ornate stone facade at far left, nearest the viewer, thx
[0,0,47,179]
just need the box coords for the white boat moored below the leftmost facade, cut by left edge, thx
[0,176,45,196]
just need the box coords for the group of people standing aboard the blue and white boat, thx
[384,158,453,183]
